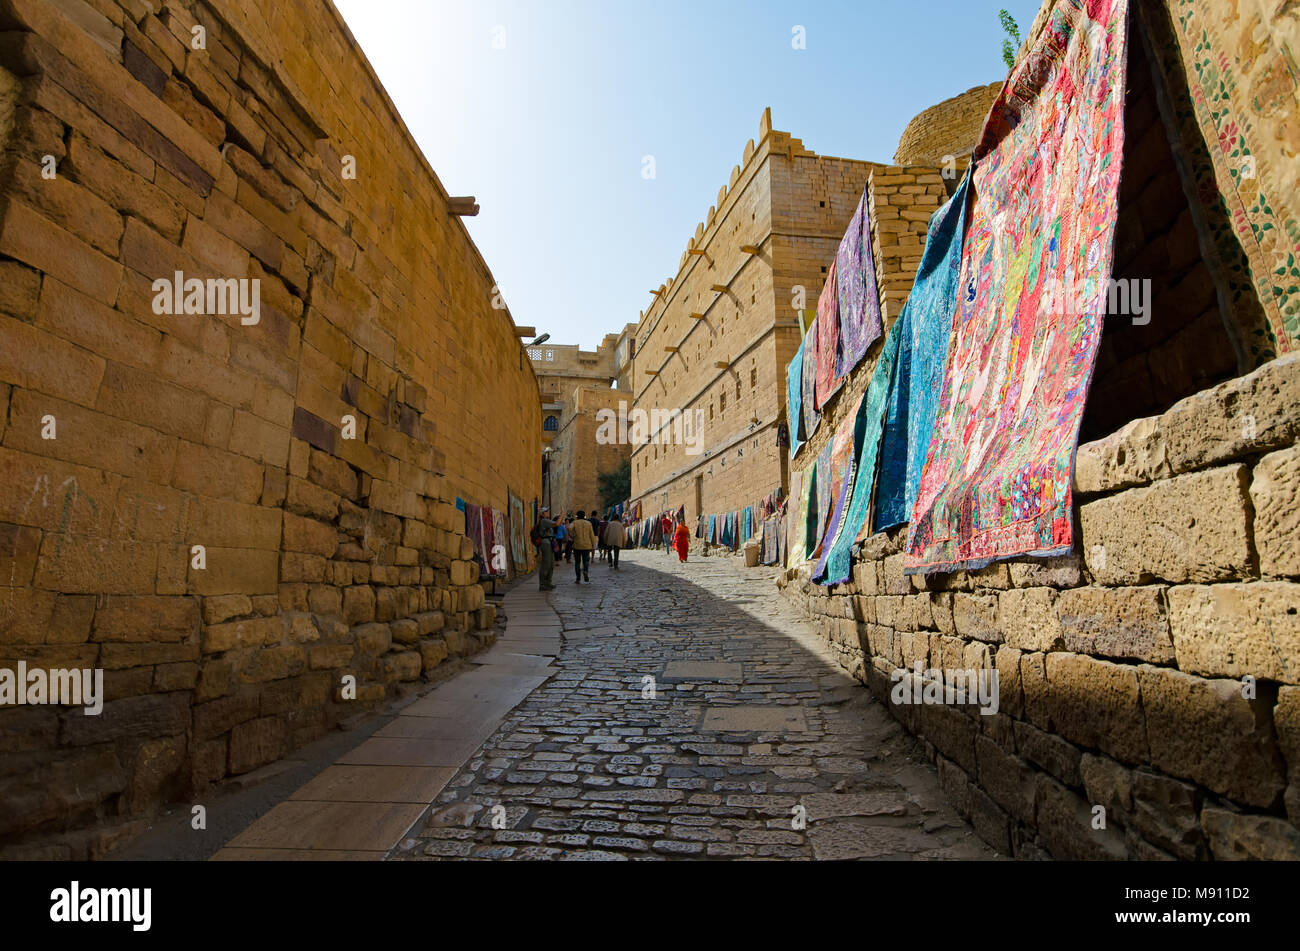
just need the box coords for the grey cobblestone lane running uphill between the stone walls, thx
[389,550,995,860]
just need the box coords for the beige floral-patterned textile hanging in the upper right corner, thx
[1134,0,1300,373]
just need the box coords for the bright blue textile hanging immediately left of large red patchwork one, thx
[872,171,970,531]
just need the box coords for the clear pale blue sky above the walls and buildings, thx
[335,0,1039,348]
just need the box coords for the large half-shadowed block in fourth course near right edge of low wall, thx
[1136,664,1286,805]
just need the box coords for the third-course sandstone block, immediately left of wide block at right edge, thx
[1057,585,1174,664]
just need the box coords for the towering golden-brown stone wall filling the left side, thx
[0,0,540,857]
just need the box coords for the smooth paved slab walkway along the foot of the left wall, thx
[206,578,560,861]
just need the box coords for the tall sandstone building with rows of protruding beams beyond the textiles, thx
[632,112,880,518]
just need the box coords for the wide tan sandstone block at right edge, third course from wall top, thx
[1169,582,1300,683]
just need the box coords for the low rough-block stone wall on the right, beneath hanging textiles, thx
[779,355,1300,859]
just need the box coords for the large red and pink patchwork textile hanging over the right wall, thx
[905,0,1128,572]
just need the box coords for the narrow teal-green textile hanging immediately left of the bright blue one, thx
[814,311,904,585]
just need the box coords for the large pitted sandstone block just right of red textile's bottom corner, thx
[1080,465,1251,586]
